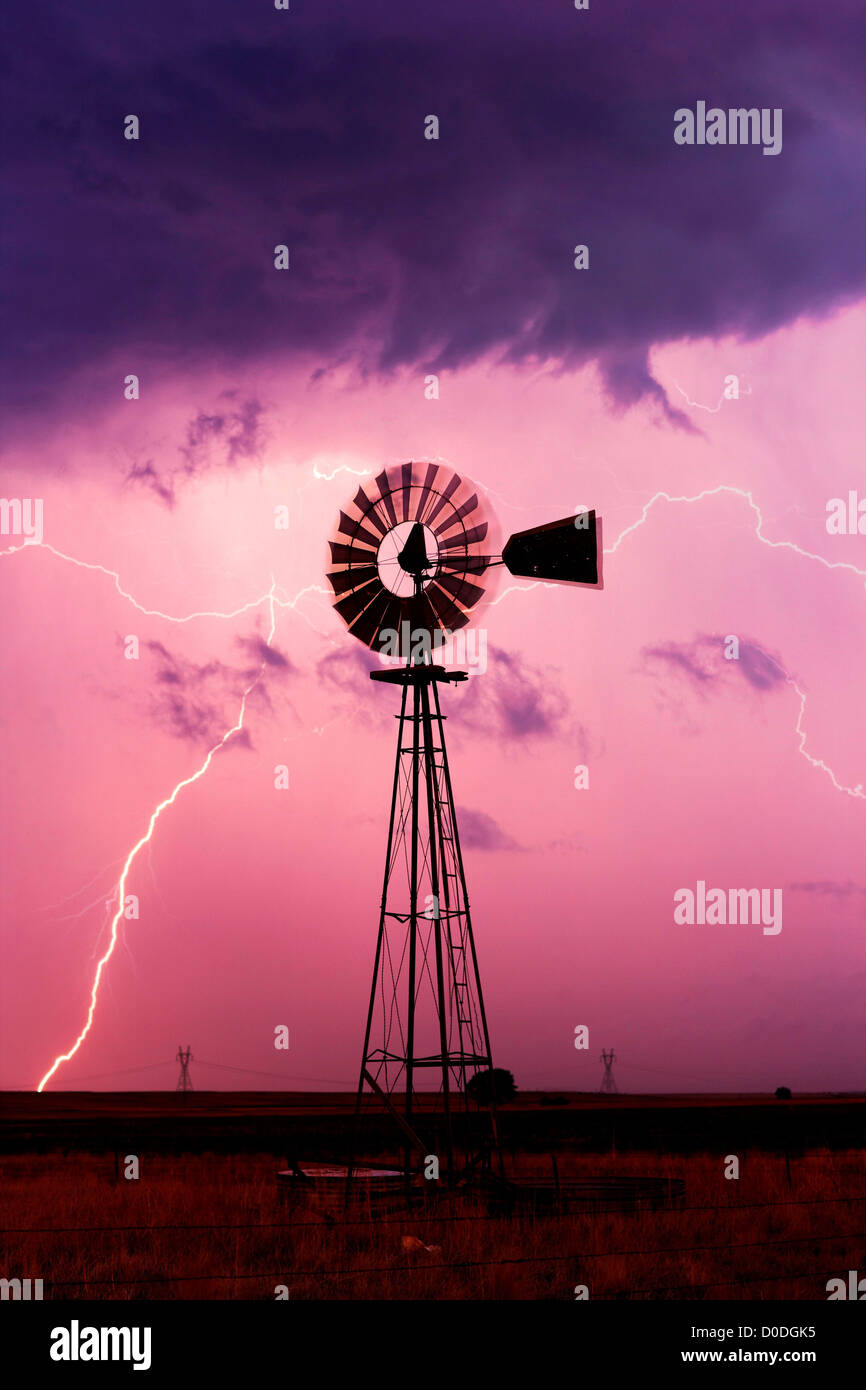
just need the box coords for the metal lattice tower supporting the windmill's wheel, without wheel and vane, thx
[357,633,496,1177]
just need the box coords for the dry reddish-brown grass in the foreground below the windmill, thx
[0,1151,866,1300]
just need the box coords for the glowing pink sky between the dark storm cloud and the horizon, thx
[0,306,866,1091]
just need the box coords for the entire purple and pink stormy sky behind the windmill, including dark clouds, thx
[0,0,866,1090]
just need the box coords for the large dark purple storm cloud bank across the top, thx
[3,0,866,428]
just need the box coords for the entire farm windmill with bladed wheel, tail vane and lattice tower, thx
[328,463,601,1183]
